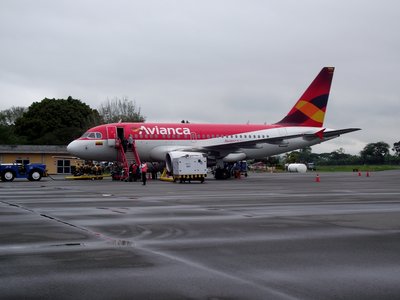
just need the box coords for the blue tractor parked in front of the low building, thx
[0,163,47,181]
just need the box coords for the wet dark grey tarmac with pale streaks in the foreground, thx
[0,171,400,300]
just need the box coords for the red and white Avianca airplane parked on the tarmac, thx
[67,67,360,177]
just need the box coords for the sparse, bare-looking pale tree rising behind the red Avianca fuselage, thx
[98,97,145,123]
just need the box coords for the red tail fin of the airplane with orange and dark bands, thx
[276,67,335,127]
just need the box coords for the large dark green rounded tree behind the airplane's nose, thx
[15,96,101,145]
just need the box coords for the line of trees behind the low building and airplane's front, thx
[0,96,145,145]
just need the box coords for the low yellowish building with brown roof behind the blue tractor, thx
[0,145,82,174]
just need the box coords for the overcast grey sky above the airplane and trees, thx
[0,0,400,154]
